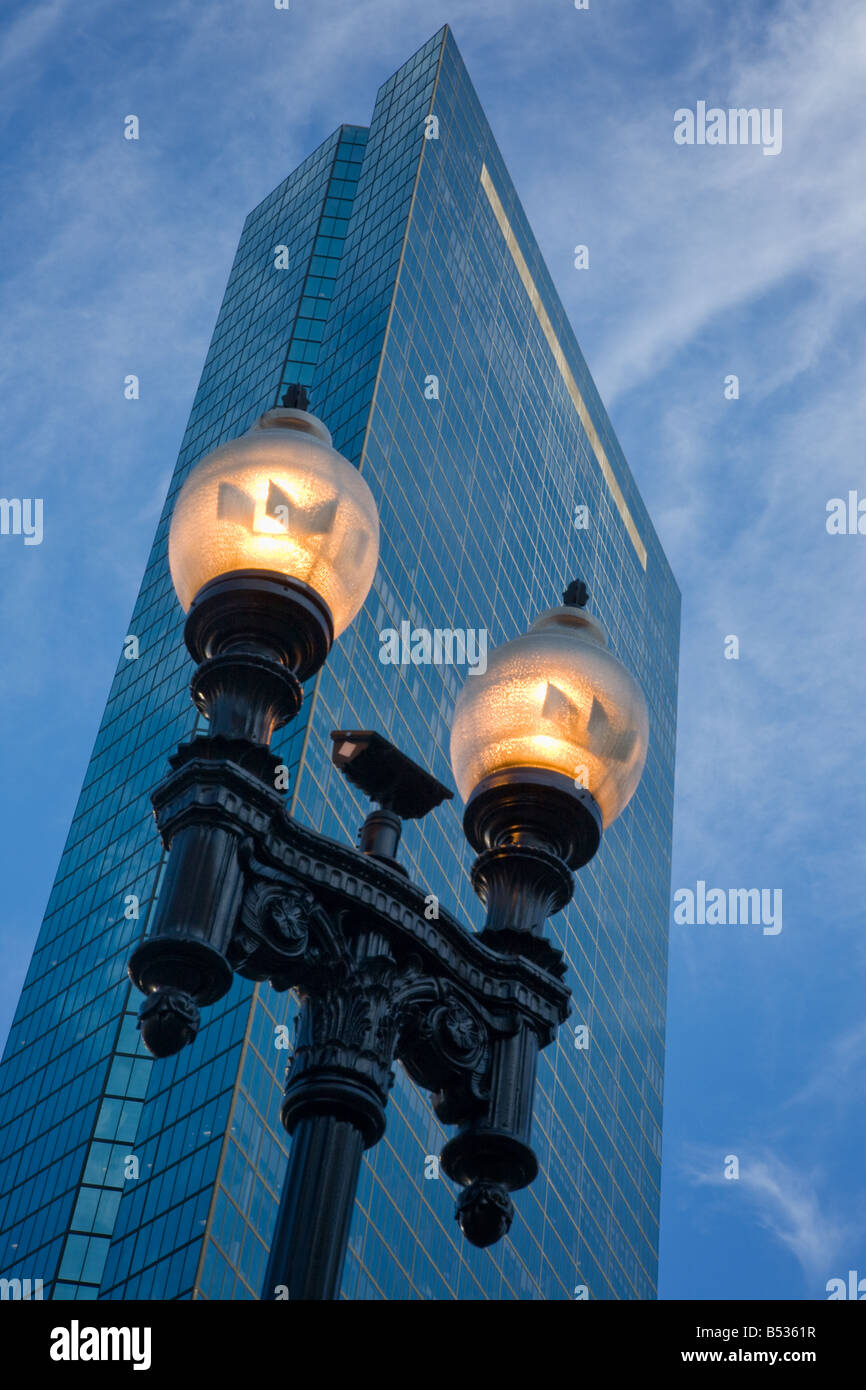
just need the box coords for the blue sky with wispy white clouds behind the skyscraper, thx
[0,0,866,1298]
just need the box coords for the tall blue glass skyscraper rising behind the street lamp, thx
[0,29,680,1298]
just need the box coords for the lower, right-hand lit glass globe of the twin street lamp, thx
[450,606,649,828]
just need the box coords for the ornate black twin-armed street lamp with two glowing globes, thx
[129,393,646,1300]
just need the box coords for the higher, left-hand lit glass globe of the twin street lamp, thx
[168,409,379,637]
